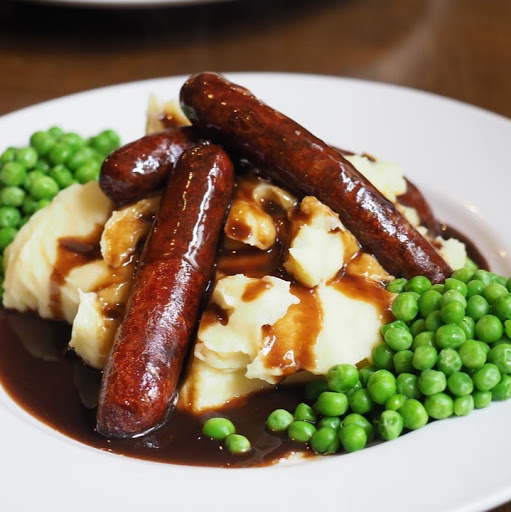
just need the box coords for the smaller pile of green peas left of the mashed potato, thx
[0,126,120,297]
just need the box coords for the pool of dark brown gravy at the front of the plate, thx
[0,309,308,467]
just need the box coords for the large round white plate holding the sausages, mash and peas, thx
[0,73,511,512]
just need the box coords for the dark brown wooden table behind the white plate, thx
[0,0,511,512]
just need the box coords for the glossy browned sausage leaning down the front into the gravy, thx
[97,145,234,438]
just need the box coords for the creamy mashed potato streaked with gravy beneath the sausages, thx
[4,143,466,411]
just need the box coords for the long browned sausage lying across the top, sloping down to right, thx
[180,73,452,283]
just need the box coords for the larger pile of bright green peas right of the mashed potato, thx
[260,268,511,454]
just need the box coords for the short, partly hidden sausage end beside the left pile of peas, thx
[99,126,198,206]
